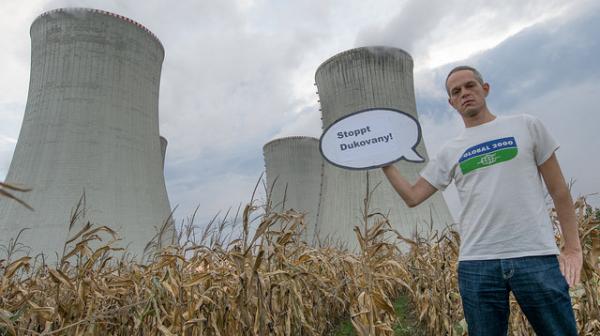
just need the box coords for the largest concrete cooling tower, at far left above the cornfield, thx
[0,9,174,260]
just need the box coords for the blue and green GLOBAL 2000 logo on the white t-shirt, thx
[458,137,518,175]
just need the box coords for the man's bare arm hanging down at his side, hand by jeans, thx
[538,154,583,287]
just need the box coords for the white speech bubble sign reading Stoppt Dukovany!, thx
[319,108,425,170]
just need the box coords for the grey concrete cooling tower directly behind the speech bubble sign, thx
[315,47,453,249]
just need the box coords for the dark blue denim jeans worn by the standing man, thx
[458,255,577,336]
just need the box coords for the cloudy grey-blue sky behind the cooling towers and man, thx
[0,0,600,227]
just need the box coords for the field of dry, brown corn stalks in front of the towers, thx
[0,184,600,336]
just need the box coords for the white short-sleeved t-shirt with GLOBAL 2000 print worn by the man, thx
[421,115,559,260]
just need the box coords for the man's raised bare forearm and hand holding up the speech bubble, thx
[382,165,437,208]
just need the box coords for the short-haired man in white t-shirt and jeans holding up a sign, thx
[383,66,582,336]
